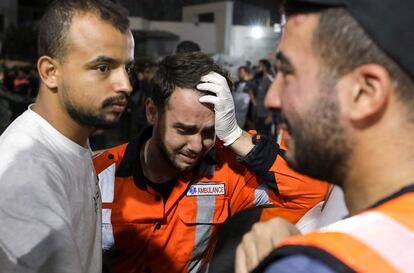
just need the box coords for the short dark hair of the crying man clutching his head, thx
[151,52,233,112]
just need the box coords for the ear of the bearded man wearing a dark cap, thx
[348,64,392,126]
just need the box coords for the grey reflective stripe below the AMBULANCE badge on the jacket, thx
[188,196,216,272]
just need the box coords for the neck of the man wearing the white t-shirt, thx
[33,92,93,148]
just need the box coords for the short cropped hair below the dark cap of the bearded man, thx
[313,8,414,113]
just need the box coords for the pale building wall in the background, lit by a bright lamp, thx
[130,1,279,63]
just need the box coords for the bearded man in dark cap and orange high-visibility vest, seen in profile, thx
[236,0,414,273]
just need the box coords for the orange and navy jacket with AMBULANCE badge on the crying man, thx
[94,129,328,273]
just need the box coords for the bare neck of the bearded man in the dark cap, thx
[343,117,414,215]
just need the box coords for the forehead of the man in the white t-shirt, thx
[66,12,134,59]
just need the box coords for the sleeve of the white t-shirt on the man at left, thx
[0,156,84,272]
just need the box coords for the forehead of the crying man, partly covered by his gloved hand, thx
[166,87,214,124]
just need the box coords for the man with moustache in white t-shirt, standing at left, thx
[0,0,134,273]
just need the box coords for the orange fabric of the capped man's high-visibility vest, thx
[278,193,414,273]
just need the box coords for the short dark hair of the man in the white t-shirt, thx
[38,0,129,58]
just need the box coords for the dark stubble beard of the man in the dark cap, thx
[287,77,351,186]
